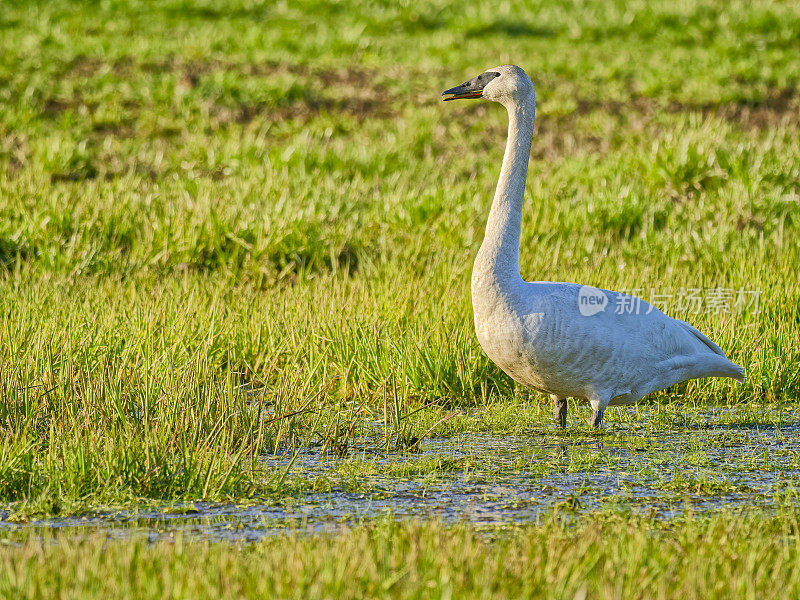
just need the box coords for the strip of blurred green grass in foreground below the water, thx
[0,509,800,599]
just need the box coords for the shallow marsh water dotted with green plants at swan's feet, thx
[0,408,800,540]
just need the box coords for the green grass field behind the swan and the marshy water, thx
[0,2,800,507]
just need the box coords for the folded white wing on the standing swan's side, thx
[529,282,743,395]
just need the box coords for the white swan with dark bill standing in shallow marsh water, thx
[442,65,744,427]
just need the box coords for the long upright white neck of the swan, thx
[472,96,535,294]
